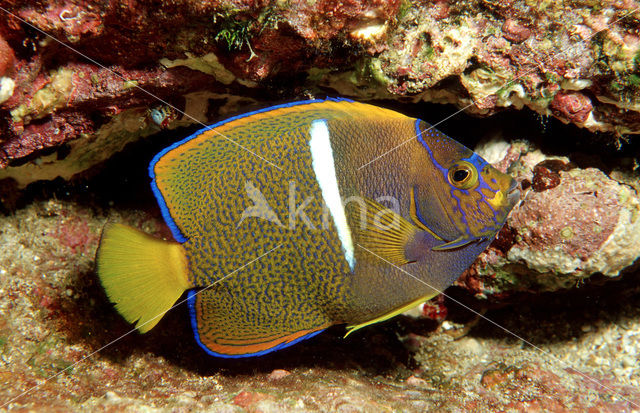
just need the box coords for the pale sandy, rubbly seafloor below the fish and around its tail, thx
[0,192,640,412]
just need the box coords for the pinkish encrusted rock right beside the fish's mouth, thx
[458,141,640,298]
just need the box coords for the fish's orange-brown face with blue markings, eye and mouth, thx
[412,121,520,249]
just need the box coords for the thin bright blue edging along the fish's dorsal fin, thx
[148,98,353,243]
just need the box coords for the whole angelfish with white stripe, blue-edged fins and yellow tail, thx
[96,98,519,357]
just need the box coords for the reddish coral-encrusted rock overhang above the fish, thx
[0,0,640,185]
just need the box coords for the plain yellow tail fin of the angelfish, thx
[96,224,193,333]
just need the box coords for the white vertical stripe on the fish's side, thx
[309,119,356,271]
